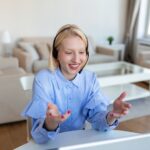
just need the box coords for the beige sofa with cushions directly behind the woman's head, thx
[14,37,118,73]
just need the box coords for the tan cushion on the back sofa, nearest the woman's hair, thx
[35,43,50,59]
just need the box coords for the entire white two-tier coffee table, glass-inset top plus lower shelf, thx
[86,61,150,100]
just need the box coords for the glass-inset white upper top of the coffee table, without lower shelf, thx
[86,61,150,87]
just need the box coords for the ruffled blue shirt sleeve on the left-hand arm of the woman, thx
[22,71,59,143]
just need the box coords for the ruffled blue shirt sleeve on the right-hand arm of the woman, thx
[83,75,118,131]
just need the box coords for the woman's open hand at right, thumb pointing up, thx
[107,92,132,125]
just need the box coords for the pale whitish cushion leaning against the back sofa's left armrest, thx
[18,42,39,61]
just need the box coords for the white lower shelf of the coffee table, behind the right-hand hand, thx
[102,84,150,103]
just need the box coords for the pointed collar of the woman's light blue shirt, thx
[55,68,81,88]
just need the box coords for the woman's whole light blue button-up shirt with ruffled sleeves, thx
[23,68,118,143]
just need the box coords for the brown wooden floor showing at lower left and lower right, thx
[0,84,150,150]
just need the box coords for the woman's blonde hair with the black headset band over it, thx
[49,24,89,71]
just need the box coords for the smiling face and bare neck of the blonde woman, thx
[57,36,87,80]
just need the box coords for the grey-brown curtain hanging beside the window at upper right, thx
[125,0,141,63]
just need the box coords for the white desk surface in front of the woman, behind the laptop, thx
[16,130,137,150]
